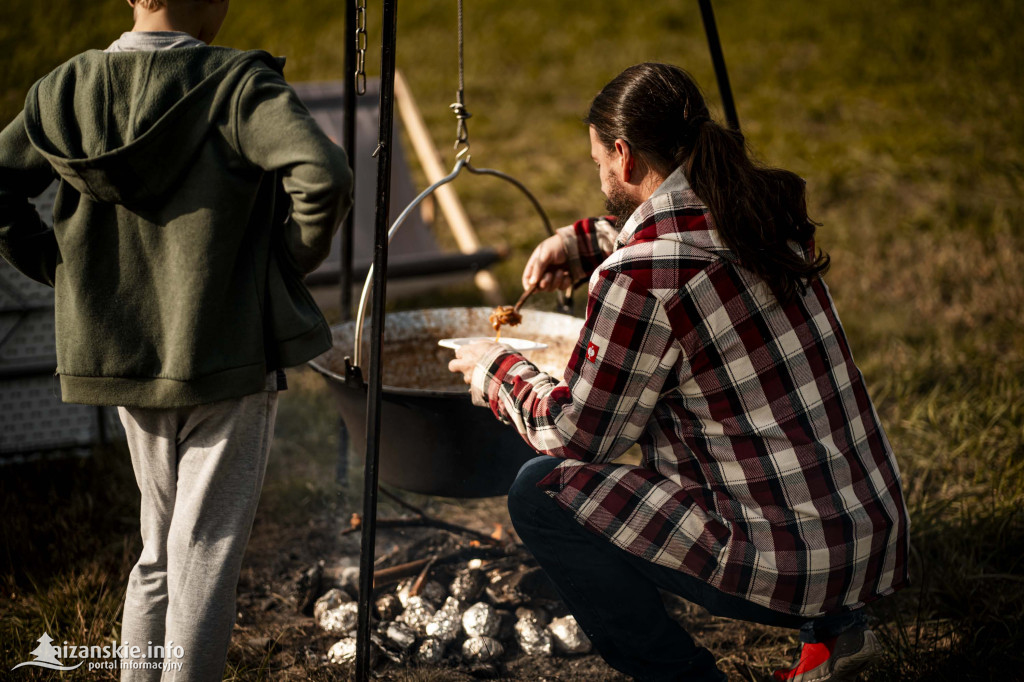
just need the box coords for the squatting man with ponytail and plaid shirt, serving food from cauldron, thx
[450,63,909,682]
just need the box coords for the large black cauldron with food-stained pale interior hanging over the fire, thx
[309,307,583,498]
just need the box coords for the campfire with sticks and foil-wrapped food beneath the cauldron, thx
[308,491,591,676]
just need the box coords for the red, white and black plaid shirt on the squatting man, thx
[472,166,909,616]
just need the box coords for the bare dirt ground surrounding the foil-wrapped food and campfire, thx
[228,481,799,682]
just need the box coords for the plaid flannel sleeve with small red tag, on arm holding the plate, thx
[471,270,680,462]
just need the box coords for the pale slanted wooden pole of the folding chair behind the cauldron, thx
[394,72,502,305]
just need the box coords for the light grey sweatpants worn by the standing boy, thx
[119,378,278,682]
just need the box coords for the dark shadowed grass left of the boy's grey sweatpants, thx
[0,443,141,680]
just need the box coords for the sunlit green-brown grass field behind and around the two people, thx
[0,0,1024,681]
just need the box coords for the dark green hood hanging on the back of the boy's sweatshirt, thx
[25,47,284,206]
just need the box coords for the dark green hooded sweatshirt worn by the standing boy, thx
[0,47,352,408]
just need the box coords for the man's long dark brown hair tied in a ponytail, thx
[585,62,828,303]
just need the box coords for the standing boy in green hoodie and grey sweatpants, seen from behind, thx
[0,0,352,680]
